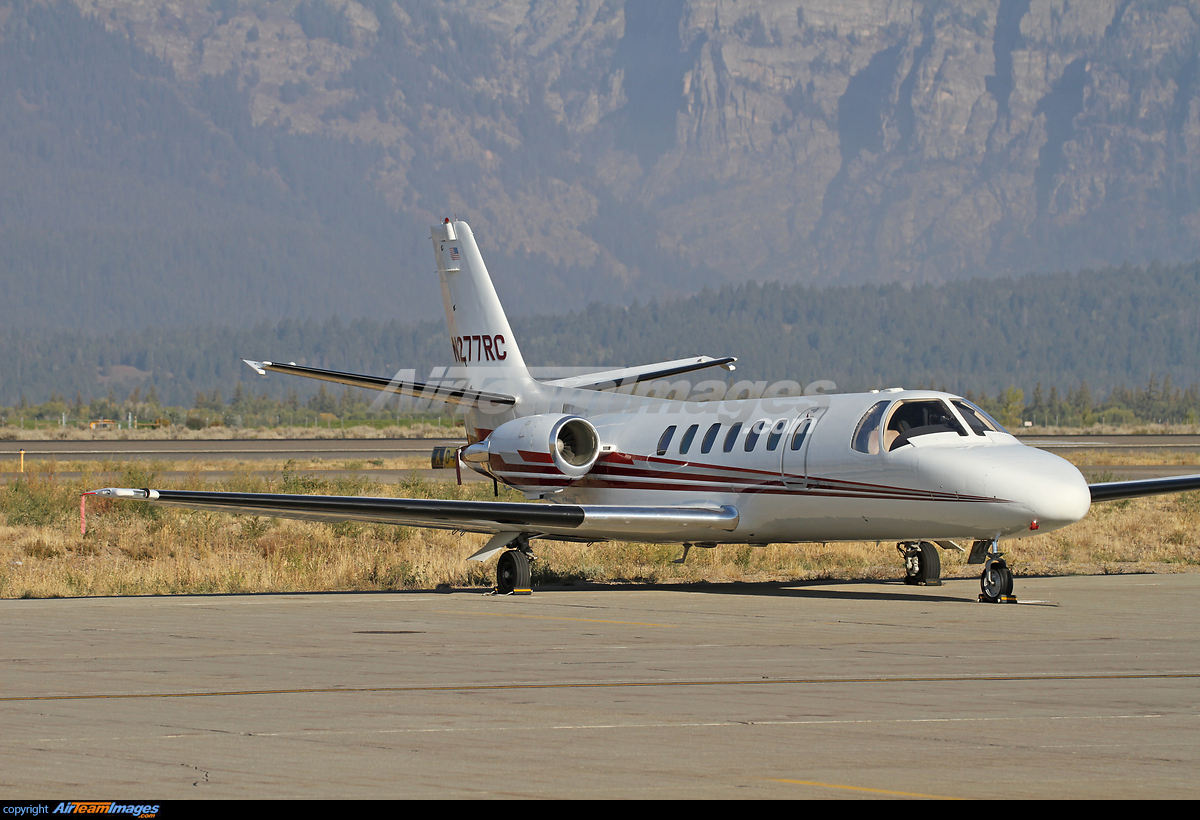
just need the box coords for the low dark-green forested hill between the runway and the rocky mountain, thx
[0,263,1200,419]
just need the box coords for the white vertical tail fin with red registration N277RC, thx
[432,217,529,374]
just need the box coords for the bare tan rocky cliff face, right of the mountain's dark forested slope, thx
[76,0,1200,291]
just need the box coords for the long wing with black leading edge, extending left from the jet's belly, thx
[85,487,738,541]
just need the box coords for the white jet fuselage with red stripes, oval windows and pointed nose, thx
[453,383,1091,544]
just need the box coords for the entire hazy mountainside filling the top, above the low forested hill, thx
[0,0,1200,330]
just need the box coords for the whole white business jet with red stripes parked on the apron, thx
[90,219,1200,601]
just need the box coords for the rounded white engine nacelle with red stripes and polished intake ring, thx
[463,413,600,491]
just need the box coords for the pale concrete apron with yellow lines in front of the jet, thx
[0,574,1200,800]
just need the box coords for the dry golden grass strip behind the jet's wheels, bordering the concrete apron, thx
[0,453,1200,598]
